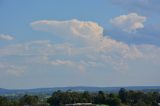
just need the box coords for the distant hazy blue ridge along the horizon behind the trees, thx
[0,86,160,95]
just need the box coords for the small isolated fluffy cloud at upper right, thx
[110,13,147,32]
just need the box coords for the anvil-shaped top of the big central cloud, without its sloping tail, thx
[31,19,103,41]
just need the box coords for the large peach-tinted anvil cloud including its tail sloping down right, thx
[31,19,138,55]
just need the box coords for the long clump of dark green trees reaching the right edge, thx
[47,88,160,106]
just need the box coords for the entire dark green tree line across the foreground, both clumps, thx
[0,88,160,106]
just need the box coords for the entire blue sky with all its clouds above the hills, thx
[0,0,160,89]
